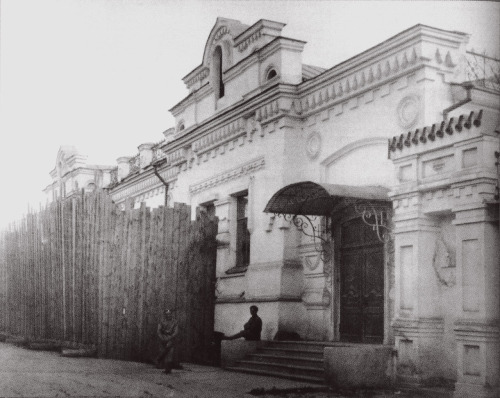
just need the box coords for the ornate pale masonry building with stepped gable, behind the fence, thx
[47,18,500,396]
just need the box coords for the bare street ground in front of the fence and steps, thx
[0,343,430,398]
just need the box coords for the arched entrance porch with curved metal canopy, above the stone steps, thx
[264,181,394,344]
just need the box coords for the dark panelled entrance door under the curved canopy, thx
[340,218,384,344]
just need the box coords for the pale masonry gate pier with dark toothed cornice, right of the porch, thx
[389,104,500,388]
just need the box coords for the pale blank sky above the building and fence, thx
[0,0,500,229]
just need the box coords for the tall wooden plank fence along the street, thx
[0,192,217,362]
